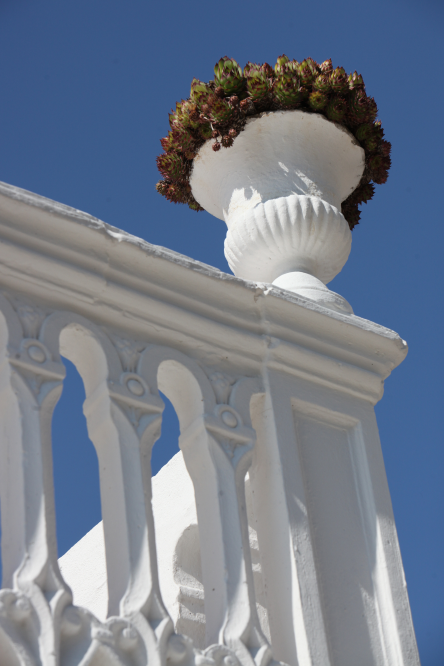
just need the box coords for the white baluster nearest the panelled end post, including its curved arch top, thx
[141,348,280,666]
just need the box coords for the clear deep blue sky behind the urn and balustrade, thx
[0,0,444,666]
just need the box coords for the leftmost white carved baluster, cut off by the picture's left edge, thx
[0,298,71,666]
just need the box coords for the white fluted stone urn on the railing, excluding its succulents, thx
[190,110,365,313]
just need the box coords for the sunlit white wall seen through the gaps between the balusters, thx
[59,452,269,648]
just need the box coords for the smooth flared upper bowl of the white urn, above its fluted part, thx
[189,109,365,226]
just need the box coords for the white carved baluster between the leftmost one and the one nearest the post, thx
[40,316,173,664]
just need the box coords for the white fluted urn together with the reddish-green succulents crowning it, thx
[157,56,391,313]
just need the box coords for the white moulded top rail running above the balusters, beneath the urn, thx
[0,179,407,402]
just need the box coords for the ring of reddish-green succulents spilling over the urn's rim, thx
[156,54,391,229]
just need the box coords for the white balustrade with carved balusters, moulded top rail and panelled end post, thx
[0,185,419,666]
